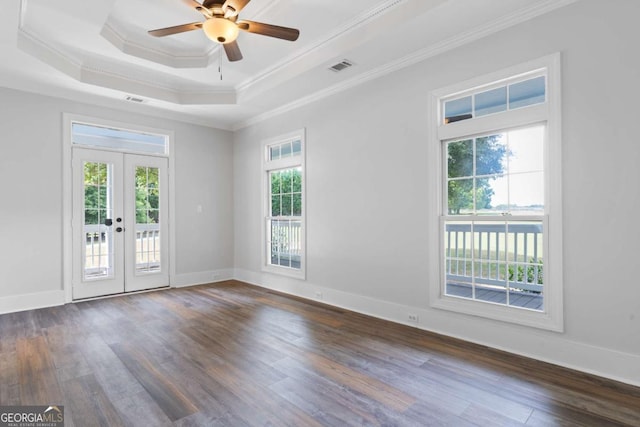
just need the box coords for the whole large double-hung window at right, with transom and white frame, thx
[430,56,562,330]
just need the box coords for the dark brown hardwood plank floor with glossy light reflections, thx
[0,282,640,427]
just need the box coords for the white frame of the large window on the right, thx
[428,53,564,332]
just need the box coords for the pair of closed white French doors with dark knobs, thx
[73,148,169,299]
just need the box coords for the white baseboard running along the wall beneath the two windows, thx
[235,269,640,387]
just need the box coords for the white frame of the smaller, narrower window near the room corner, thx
[261,128,307,280]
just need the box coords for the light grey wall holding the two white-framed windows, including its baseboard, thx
[234,0,640,385]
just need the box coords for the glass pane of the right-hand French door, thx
[135,166,161,274]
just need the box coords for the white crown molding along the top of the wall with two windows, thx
[232,0,580,131]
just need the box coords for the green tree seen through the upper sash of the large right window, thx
[447,135,509,214]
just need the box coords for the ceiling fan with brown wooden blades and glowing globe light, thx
[149,0,300,61]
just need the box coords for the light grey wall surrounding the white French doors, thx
[0,89,233,312]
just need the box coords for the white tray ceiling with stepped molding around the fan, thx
[0,0,575,129]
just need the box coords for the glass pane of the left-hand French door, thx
[82,162,114,280]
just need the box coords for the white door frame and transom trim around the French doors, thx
[62,113,176,303]
